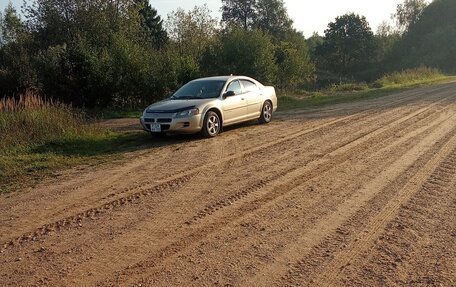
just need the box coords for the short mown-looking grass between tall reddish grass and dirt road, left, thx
[0,131,163,193]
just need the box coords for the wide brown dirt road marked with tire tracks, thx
[0,84,456,286]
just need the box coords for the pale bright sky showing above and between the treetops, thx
[0,0,403,37]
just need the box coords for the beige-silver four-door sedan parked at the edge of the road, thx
[140,76,277,137]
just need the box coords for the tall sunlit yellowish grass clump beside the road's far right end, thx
[375,67,444,87]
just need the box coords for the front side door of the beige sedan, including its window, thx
[222,80,247,124]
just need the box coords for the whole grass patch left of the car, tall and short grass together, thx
[0,92,160,193]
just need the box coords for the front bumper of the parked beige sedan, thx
[140,113,201,133]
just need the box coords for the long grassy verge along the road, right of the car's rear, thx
[279,67,456,111]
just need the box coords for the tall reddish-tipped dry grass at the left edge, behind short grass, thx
[0,91,88,151]
